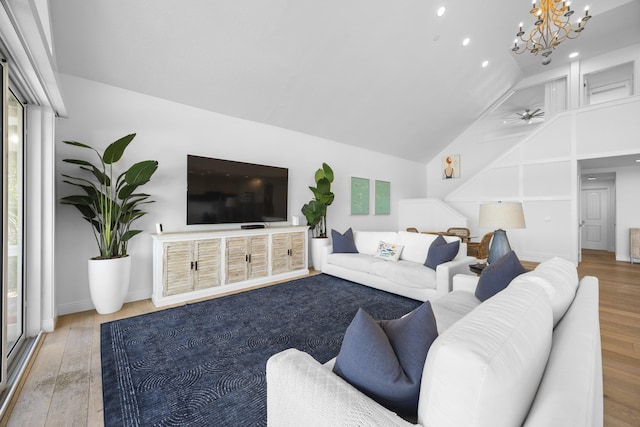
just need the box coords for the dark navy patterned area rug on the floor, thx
[101,274,420,426]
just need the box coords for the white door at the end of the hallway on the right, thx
[581,189,609,251]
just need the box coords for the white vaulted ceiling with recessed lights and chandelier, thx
[49,0,640,162]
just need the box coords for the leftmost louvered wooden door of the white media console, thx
[162,242,193,296]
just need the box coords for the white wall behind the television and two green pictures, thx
[56,75,426,314]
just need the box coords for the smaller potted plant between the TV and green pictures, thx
[302,163,335,269]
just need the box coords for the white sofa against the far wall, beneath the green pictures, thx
[321,231,477,301]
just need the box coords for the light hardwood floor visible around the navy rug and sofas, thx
[0,251,640,427]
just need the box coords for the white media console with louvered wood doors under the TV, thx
[151,226,309,307]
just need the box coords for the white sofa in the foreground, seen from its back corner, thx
[267,259,603,427]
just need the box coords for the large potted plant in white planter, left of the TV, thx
[60,133,158,314]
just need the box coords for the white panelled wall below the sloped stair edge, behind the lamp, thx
[445,96,640,263]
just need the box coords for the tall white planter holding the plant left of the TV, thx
[89,255,131,314]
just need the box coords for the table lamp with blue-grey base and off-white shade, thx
[478,202,525,264]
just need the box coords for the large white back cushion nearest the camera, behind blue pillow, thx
[418,287,552,427]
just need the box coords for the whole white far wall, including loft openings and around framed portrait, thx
[427,44,640,262]
